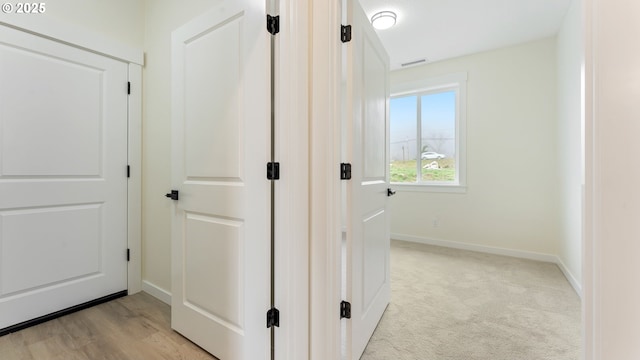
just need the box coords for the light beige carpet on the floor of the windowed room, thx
[361,241,581,360]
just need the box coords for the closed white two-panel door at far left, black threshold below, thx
[0,26,127,329]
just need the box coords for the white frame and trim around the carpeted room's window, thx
[391,72,467,193]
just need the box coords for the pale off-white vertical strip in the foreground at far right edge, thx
[583,0,640,360]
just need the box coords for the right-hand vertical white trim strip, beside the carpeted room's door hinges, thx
[309,0,342,360]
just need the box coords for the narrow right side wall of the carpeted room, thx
[557,0,584,292]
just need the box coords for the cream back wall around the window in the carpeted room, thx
[391,38,560,254]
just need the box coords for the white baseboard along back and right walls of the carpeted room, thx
[391,234,582,298]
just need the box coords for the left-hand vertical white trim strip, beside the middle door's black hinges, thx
[276,0,312,360]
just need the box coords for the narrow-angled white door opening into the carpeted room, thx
[345,0,391,359]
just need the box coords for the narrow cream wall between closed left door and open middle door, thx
[142,0,220,300]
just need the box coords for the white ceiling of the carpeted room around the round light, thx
[360,0,571,69]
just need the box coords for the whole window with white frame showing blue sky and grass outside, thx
[389,74,466,190]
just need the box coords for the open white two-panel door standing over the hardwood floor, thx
[168,0,270,360]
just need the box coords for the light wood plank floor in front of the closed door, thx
[0,293,216,360]
